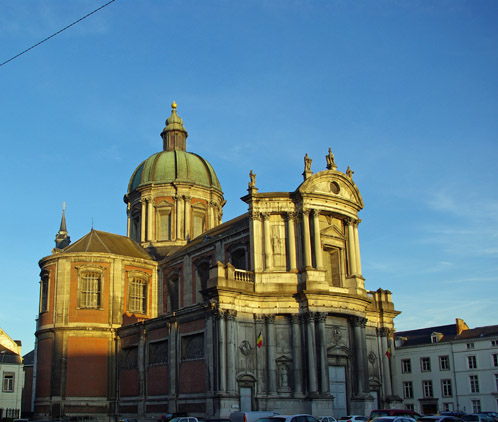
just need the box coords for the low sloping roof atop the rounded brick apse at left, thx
[63,229,152,259]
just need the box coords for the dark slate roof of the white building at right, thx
[395,324,498,348]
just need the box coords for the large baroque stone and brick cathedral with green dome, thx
[33,103,399,421]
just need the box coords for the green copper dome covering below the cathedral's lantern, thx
[128,150,221,193]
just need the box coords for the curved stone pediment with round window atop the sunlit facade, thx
[297,170,363,210]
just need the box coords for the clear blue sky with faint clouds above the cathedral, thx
[0,0,498,353]
